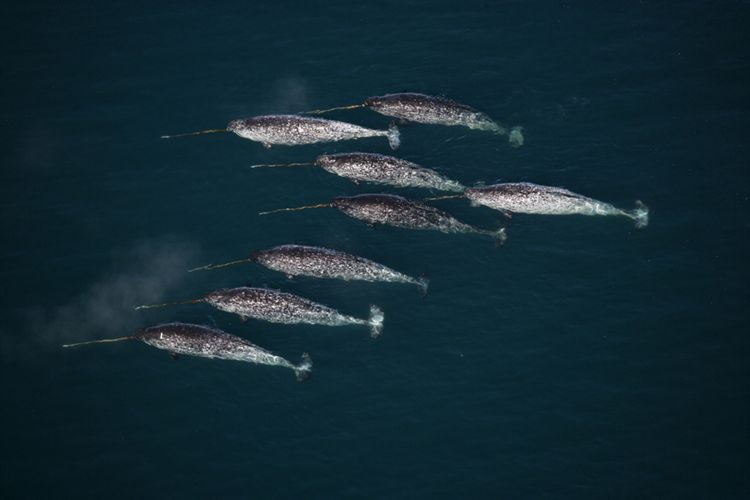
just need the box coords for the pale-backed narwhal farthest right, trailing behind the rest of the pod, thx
[432,182,648,228]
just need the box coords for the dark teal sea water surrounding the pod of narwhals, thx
[0,0,750,499]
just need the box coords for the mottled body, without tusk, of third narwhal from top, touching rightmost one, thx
[315,153,464,191]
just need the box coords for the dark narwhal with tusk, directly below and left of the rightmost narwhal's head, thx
[260,194,506,245]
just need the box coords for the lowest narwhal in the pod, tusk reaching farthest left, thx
[63,323,312,381]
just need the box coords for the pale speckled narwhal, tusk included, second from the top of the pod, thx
[161,115,401,149]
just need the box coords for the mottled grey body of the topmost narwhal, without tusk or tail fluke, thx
[364,92,506,135]
